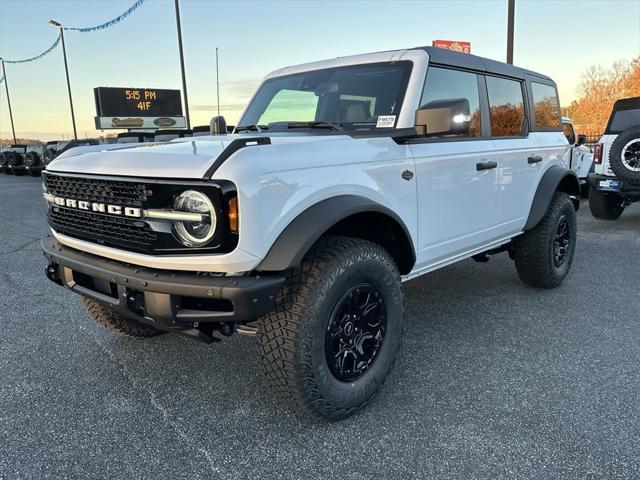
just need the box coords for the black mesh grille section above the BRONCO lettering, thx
[44,175,153,207]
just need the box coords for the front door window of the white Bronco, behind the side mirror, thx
[420,67,481,137]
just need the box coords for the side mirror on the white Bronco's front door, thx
[416,98,471,136]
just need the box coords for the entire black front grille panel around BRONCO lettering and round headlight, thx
[43,172,238,255]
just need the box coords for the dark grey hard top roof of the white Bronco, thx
[418,47,555,85]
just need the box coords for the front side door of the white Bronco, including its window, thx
[411,67,499,269]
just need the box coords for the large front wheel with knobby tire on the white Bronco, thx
[257,237,404,420]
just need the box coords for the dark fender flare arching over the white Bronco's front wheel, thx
[256,195,416,275]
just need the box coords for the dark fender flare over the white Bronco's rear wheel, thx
[523,165,580,232]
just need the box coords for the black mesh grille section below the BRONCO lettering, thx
[49,206,158,252]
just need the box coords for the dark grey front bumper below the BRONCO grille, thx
[42,237,284,332]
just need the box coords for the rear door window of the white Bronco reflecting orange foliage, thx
[487,77,524,137]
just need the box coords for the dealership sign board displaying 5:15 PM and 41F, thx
[93,87,186,130]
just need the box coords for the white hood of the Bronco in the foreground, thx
[47,132,348,179]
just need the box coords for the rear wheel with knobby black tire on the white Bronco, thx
[513,192,576,288]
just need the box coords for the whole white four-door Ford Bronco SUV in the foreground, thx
[42,47,580,419]
